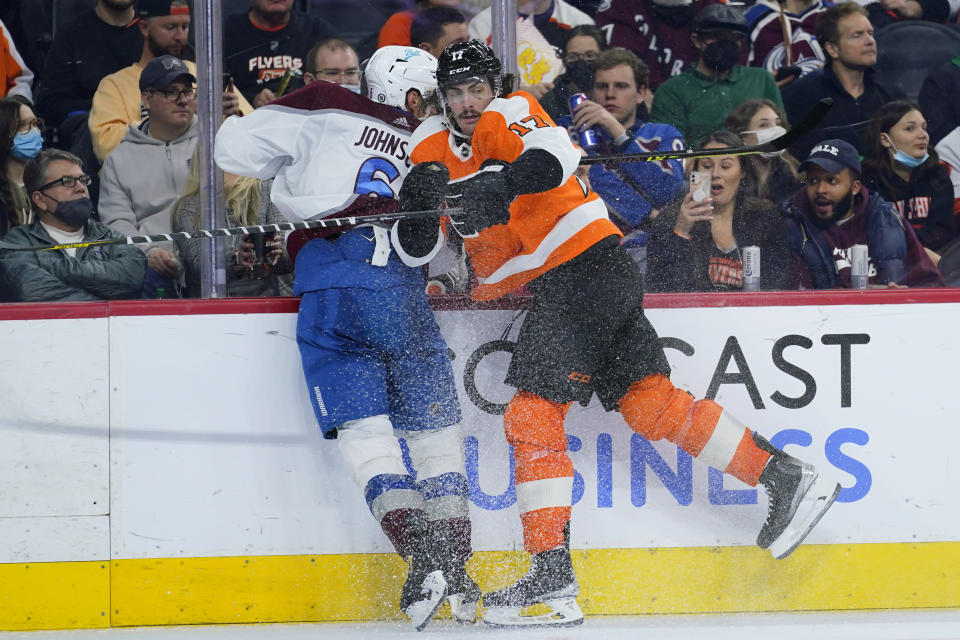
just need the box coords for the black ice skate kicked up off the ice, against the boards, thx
[757,452,840,560]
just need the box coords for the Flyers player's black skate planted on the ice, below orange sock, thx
[483,547,583,627]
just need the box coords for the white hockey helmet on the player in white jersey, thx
[363,45,437,109]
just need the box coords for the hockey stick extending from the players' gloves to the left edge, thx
[0,208,463,251]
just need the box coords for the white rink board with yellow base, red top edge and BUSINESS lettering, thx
[0,290,960,629]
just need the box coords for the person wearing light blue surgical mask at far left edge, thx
[0,96,43,236]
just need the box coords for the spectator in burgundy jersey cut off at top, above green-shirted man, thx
[595,0,704,89]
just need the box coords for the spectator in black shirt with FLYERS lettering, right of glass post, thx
[223,0,334,107]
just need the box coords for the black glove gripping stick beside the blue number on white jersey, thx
[397,162,450,258]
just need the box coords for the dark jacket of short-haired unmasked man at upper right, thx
[782,64,903,162]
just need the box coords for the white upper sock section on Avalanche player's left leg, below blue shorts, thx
[337,414,409,489]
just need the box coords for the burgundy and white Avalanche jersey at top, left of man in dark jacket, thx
[747,0,833,74]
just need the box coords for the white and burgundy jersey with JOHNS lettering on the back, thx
[214,81,418,221]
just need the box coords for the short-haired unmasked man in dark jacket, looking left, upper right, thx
[783,2,899,158]
